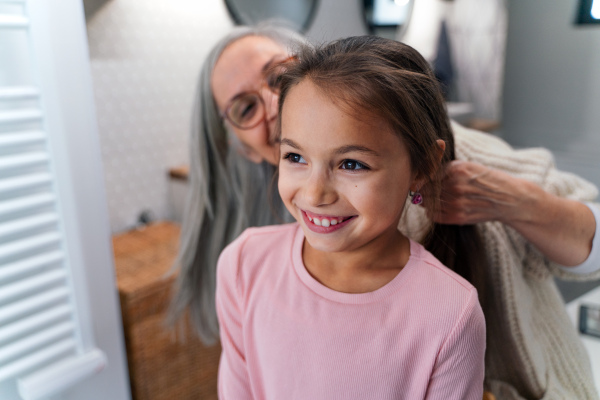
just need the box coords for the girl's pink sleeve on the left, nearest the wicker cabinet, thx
[216,240,252,400]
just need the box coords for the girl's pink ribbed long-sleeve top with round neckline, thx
[216,224,485,400]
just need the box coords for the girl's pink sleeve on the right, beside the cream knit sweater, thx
[426,289,485,400]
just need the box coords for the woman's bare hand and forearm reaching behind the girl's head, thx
[436,161,596,266]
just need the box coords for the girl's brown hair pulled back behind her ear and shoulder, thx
[279,36,485,299]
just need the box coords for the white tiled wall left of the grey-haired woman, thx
[87,0,232,232]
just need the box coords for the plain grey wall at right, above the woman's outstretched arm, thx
[502,0,600,186]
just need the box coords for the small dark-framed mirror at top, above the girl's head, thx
[363,0,414,40]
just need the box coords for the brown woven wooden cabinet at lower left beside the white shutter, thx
[113,222,221,400]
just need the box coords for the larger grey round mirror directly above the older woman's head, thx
[225,0,318,32]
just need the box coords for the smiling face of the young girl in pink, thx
[279,79,417,252]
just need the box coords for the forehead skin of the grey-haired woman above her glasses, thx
[211,36,287,111]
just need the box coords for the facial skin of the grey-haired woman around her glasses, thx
[211,36,288,164]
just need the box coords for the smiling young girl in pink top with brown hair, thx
[216,37,485,400]
